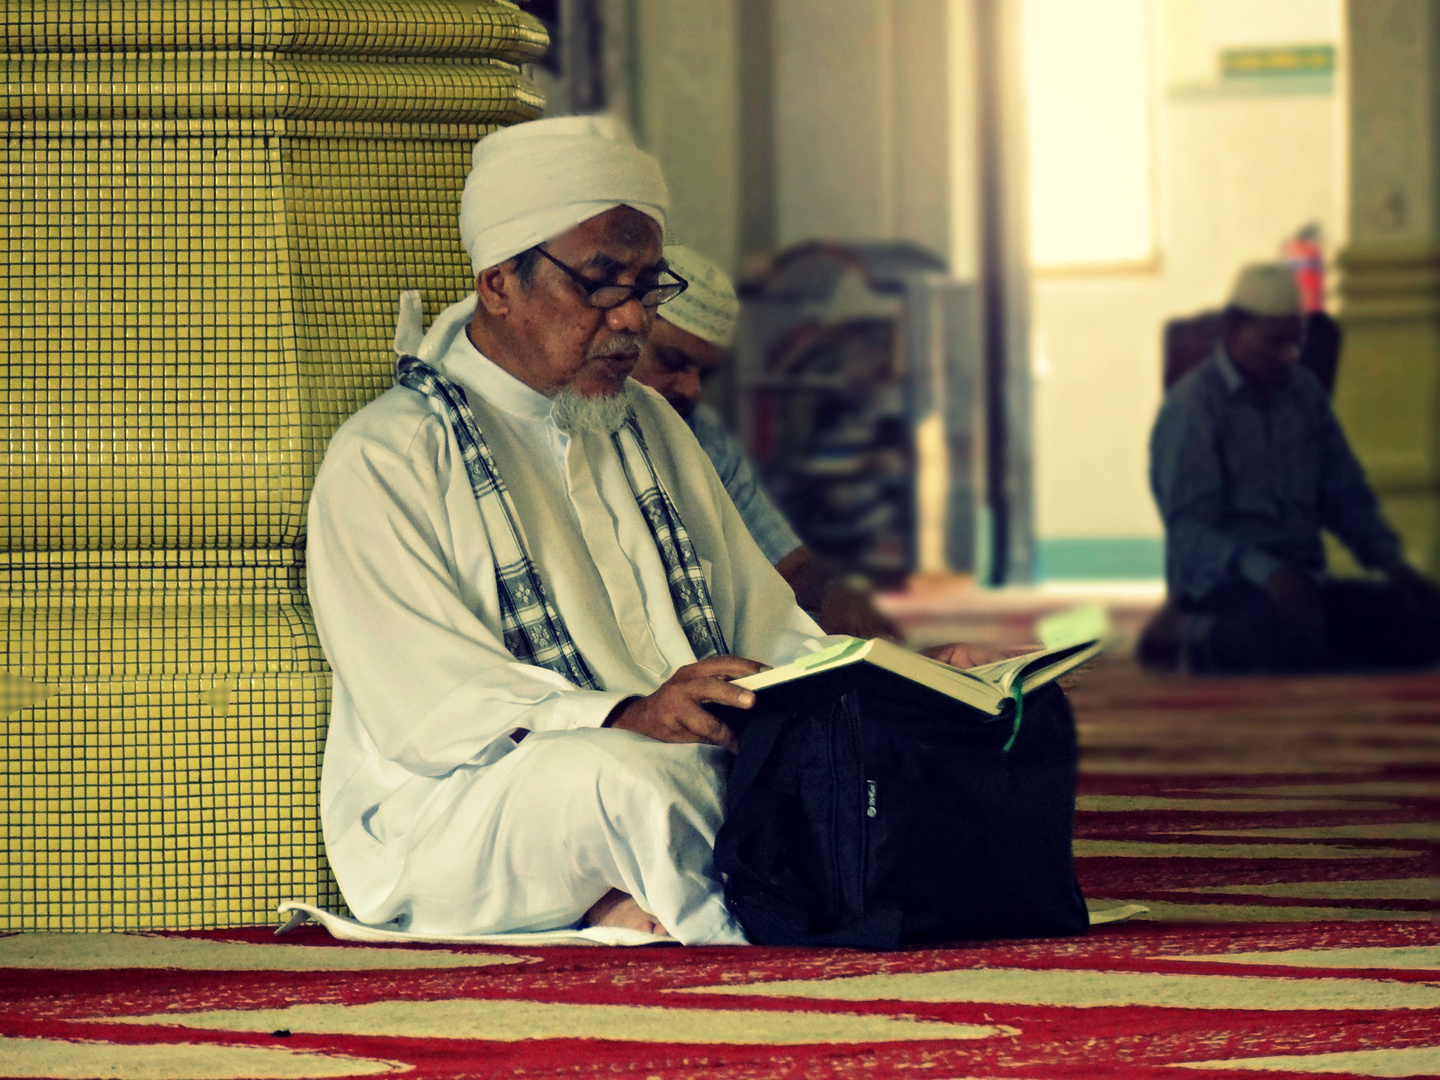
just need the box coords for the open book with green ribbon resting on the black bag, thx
[734,638,1106,716]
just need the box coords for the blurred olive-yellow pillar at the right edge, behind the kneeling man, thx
[1335,0,1440,572]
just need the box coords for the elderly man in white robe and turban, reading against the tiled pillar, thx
[308,117,982,942]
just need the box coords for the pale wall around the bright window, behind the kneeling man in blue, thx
[1031,0,1345,539]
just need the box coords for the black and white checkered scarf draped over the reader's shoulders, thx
[395,356,729,690]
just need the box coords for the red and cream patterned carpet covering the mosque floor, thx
[0,593,1440,1080]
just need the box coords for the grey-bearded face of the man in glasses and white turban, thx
[503,206,664,397]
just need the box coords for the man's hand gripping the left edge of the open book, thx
[605,657,765,750]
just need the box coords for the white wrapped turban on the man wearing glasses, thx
[459,117,670,275]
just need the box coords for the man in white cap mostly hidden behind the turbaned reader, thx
[631,243,900,638]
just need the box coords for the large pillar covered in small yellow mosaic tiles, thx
[0,0,546,930]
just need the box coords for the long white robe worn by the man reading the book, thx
[307,334,824,942]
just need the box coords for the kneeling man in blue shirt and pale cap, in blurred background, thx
[1142,264,1440,672]
